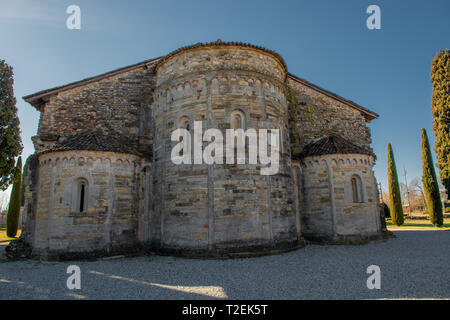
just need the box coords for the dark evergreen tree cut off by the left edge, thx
[0,60,22,190]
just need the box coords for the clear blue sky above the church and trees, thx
[0,0,450,198]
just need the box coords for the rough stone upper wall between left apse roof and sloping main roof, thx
[33,67,154,158]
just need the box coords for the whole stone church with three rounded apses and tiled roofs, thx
[18,40,382,259]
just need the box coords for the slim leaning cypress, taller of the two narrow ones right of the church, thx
[422,128,444,227]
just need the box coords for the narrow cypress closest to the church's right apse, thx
[388,143,404,226]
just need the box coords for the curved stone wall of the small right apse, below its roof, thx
[294,155,381,240]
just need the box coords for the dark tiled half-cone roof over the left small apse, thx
[40,131,141,156]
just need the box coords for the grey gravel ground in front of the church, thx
[0,231,450,299]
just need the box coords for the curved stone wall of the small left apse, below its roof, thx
[31,151,141,255]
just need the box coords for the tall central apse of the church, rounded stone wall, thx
[150,47,298,255]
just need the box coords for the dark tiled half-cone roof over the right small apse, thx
[298,135,374,159]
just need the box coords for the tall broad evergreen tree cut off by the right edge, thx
[431,49,450,196]
